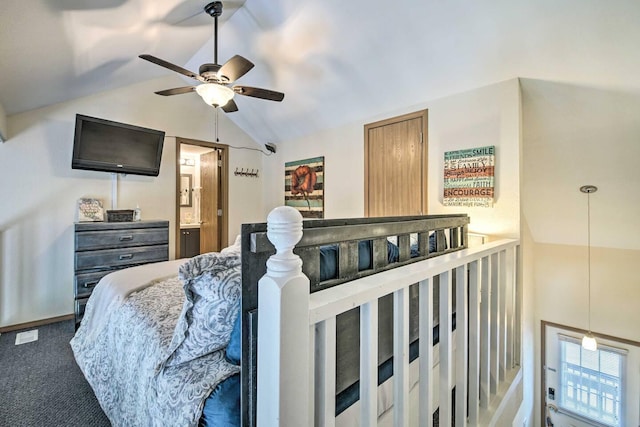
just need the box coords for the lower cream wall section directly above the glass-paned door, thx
[535,243,640,341]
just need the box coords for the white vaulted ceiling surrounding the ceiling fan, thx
[0,0,640,142]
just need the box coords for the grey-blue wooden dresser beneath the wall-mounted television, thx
[74,221,169,328]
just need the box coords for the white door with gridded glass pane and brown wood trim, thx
[540,320,640,427]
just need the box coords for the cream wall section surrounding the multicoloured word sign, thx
[427,79,520,238]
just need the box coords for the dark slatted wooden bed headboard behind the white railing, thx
[241,214,469,427]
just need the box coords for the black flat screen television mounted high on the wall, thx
[71,114,164,176]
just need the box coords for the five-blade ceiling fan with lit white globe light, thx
[139,1,284,113]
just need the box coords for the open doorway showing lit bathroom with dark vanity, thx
[175,137,229,258]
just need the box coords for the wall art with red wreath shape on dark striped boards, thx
[284,157,324,218]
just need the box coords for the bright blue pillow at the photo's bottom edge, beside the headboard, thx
[198,374,240,427]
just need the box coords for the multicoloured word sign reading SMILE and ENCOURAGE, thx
[443,145,496,208]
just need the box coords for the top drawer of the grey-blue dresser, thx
[75,228,169,251]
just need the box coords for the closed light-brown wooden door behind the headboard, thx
[364,110,428,217]
